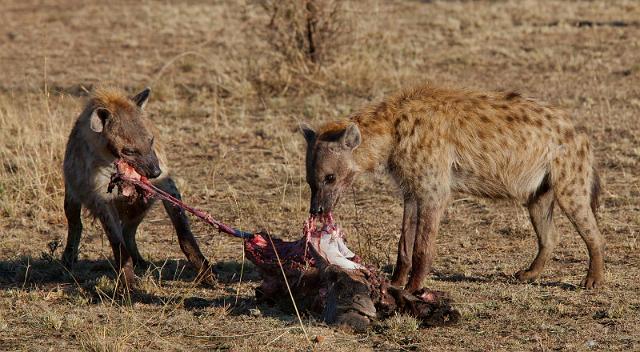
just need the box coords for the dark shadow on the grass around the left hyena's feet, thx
[0,253,259,305]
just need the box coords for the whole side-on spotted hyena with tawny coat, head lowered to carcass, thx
[302,85,604,289]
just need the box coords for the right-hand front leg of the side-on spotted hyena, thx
[407,195,448,292]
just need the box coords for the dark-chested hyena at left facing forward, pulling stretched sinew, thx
[62,88,213,286]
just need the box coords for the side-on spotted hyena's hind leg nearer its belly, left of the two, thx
[516,189,560,281]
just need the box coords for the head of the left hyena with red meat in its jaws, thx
[89,88,162,178]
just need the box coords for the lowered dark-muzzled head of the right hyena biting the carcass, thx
[301,123,361,215]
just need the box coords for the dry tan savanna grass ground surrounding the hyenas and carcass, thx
[0,0,640,351]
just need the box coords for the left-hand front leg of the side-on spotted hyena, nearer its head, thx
[391,194,418,287]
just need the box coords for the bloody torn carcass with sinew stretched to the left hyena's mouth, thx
[109,161,460,331]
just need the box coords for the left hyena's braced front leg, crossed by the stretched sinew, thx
[156,177,215,284]
